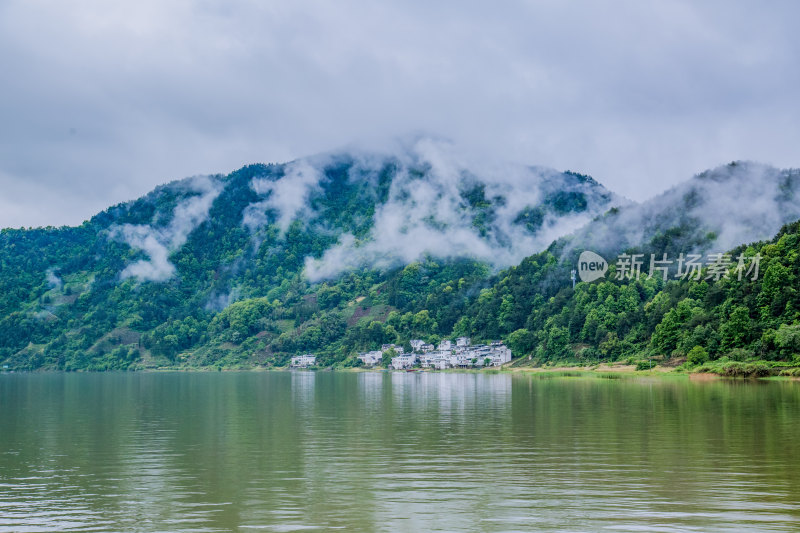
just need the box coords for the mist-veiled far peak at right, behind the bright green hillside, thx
[563,161,800,262]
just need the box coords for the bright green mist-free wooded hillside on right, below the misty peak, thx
[494,215,800,376]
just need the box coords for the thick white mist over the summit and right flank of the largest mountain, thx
[242,137,623,281]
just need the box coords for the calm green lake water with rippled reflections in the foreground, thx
[0,372,800,532]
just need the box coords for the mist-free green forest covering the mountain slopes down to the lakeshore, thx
[0,161,800,376]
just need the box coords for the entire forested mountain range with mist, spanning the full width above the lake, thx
[0,139,800,370]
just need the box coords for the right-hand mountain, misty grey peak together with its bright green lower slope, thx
[444,162,800,375]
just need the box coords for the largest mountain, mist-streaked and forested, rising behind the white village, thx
[0,139,624,369]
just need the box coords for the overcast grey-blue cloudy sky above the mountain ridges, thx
[0,0,800,227]
